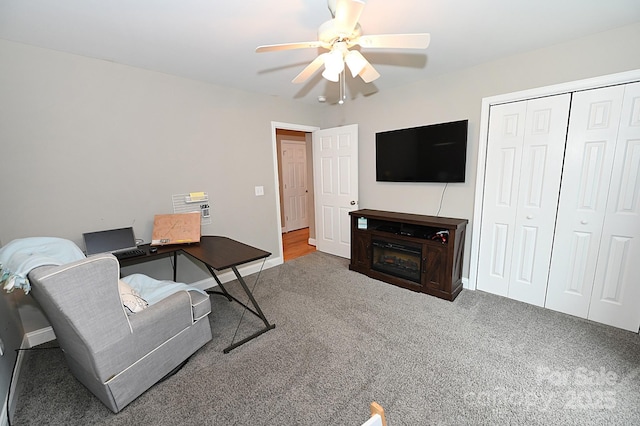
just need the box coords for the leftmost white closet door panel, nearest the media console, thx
[477,101,527,296]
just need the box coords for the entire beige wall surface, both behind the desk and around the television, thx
[0,23,640,281]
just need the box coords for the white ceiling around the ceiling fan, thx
[0,0,640,102]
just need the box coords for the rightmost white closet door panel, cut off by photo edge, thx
[588,83,640,332]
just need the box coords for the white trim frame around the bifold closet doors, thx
[467,69,640,290]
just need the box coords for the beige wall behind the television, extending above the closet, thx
[325,23,640,277]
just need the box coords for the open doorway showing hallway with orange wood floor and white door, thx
[275,127,316,262]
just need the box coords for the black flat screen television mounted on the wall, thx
[376,120,469,182]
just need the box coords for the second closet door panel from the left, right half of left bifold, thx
[508,94,571,306]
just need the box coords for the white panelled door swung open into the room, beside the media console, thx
[313,124,358,258]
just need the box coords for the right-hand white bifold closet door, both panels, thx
[546,83,640,332]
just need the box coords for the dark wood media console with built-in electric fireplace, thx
[349,209,468,300]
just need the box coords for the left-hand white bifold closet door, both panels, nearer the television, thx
[477,94,571,306]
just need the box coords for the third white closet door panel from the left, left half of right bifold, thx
[545,86,624,318]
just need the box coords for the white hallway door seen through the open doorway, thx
[280,141,309,232]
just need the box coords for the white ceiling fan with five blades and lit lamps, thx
[256,0,431,89]
